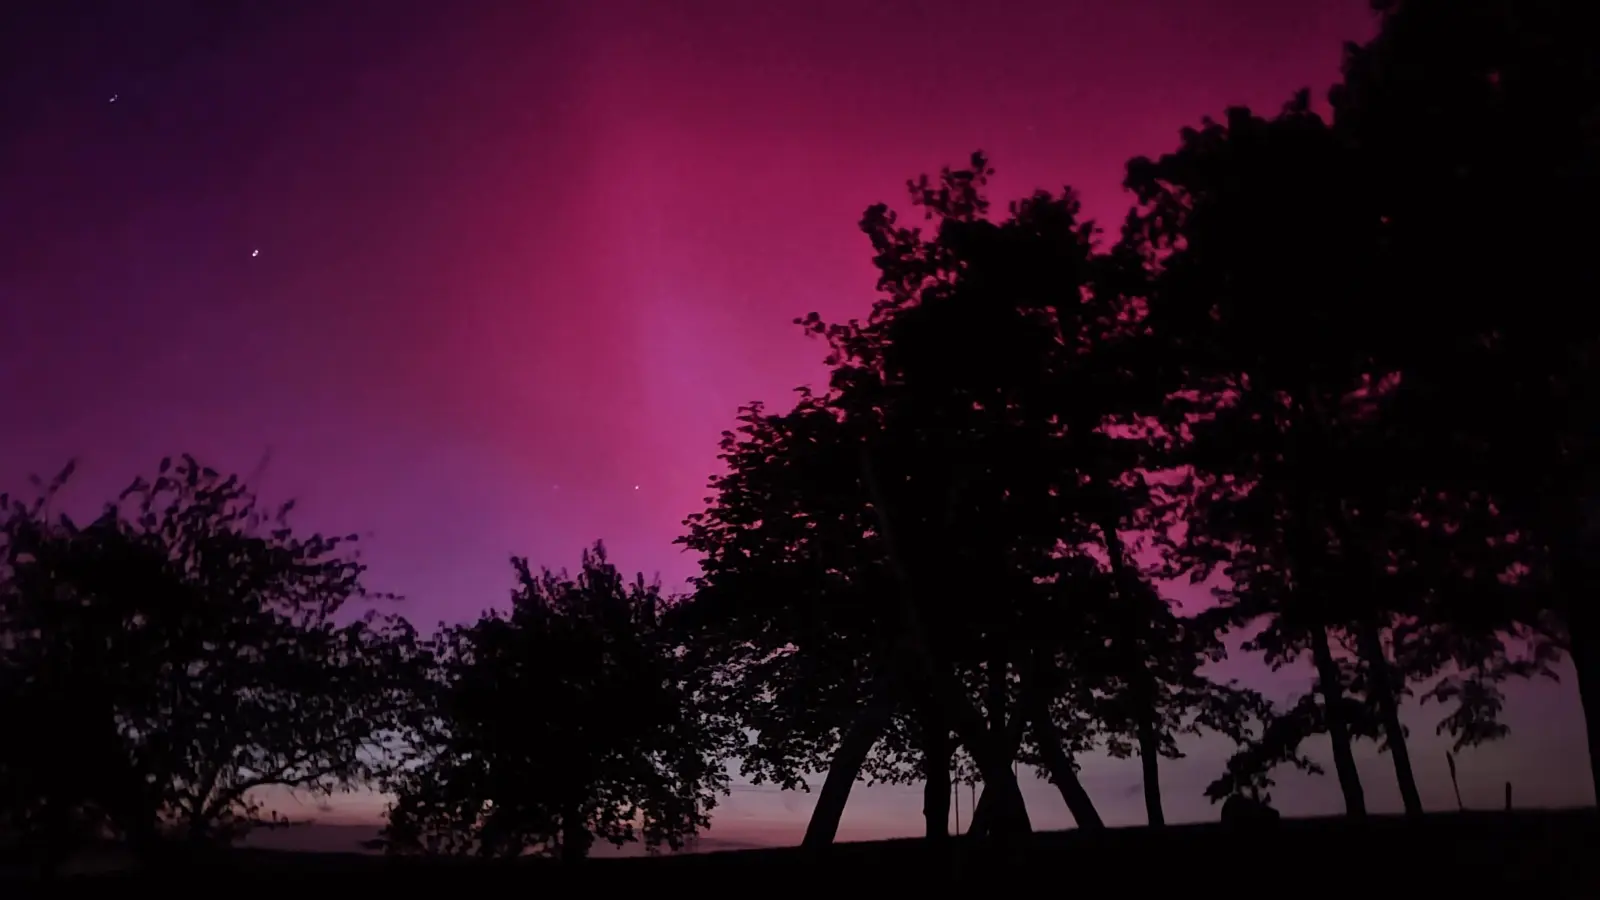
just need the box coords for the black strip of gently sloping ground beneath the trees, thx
[0,810,1600,900]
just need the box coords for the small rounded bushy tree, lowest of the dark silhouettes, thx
[384,544,731,862]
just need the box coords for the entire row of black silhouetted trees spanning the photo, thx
[0,0,1600,858]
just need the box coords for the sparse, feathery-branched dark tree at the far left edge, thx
[3,456,416,852]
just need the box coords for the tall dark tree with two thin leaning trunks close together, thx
[1126,94,1421,815]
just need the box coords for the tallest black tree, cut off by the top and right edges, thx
[1330,0,1600,791]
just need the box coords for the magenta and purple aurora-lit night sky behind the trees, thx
[0,0,1592,842]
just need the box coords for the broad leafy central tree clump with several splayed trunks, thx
[685,155,1273,844]
